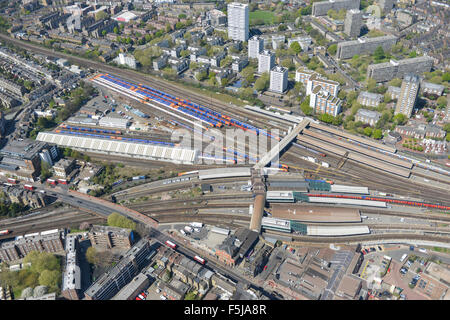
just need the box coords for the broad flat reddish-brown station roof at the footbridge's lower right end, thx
[271,203,361,223]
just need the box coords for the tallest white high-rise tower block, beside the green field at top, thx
[227,2,249,41]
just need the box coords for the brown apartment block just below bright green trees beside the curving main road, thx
[88,225,134,249]
